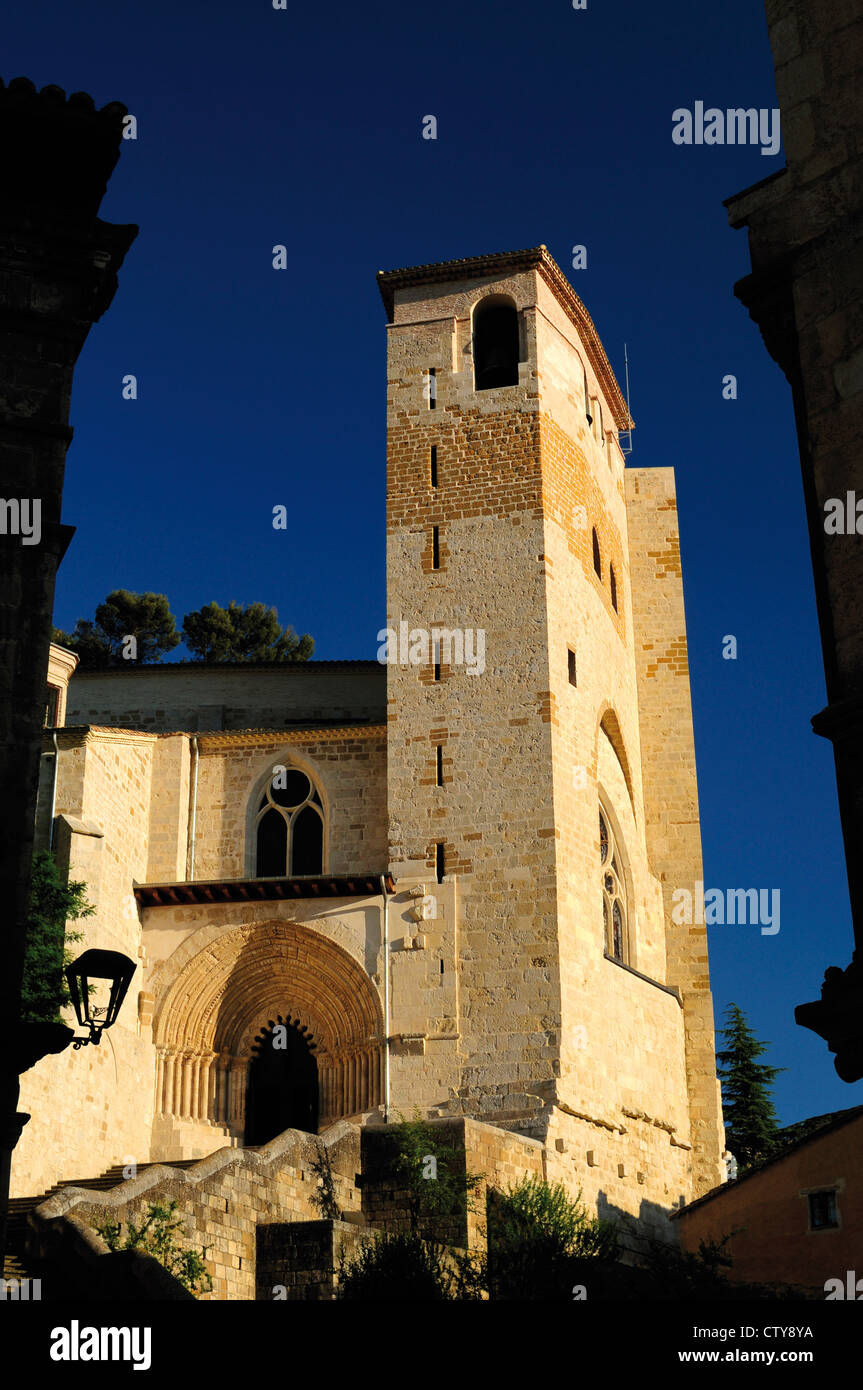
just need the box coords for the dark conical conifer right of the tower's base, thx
[716,1004,785,1173]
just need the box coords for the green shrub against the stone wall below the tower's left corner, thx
[389,1112,482,1240]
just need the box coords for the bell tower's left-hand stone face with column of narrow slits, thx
[388,262,560,1122]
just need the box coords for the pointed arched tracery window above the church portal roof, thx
[254,767,324,878]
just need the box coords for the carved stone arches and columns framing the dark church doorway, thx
[153,922,382,1138]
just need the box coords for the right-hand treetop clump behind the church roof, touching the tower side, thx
[183,599,314,663]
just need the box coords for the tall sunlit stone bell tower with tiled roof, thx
[378,246,721,1212]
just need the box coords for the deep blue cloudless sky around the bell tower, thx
[6,0,863,1123]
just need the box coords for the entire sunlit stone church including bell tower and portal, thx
[14,246,723,1227]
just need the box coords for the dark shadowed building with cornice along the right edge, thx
[725,0,863,1081]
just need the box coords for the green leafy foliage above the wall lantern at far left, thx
[21,849,96,1023]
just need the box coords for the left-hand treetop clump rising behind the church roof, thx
[54,589,181,670]
